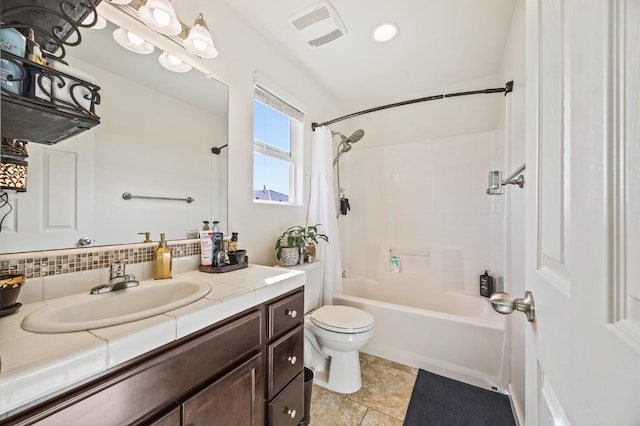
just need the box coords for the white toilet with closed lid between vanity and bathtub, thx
[284,262,374,393]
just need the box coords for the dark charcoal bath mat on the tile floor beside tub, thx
[404,370,516,426]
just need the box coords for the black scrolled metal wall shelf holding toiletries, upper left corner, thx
[0,0,101,145]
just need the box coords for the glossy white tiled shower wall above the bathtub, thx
[339,131,505,294]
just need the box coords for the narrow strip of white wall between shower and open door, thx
[500,0,527,421]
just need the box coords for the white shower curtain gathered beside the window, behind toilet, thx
[307,126,342,304]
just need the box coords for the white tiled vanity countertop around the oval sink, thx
[0,265,305,420]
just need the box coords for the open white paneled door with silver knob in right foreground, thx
[526,0,640,426]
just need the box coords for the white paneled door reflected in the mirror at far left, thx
[0,130,94,253]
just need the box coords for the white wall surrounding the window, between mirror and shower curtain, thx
[179,0,339,265]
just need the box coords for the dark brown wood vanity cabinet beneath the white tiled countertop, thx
[0,289,304,426]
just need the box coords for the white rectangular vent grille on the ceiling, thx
[289,1,347,47]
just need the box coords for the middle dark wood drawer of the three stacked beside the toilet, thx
[267,325,304,399]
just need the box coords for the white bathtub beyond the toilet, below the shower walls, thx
[333,278,509,393]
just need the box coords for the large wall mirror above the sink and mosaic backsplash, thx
[0,15,228,253]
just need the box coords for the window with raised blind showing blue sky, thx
[253,86,304,204]
